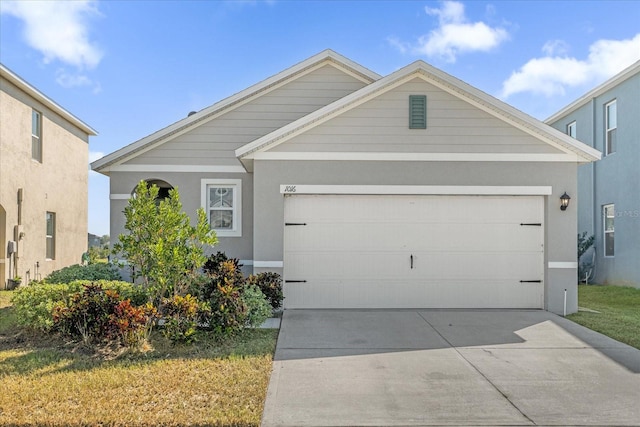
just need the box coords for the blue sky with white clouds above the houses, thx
[0,0,640,235]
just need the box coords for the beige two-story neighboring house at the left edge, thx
[0,65,96,288]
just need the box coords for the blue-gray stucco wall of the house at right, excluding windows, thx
[551,74,640,287]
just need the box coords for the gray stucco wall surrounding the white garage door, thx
[254,160,578,313]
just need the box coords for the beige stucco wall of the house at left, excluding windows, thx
[0,79,89,286]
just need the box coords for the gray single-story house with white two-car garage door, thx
[92,50,600,313]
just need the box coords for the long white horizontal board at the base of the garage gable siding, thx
[251,151,581,163]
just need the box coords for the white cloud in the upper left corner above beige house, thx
[0,0,103,69]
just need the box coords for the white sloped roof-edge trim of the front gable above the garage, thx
[236,61,600,168]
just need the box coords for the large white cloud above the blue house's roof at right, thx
[502,33,640,98]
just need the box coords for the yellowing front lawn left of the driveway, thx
[0,291,277,427]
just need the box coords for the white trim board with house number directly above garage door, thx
[280,184,552,196]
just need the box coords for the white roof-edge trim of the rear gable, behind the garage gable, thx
[91,50,380,172]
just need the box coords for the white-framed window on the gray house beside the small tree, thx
[202,179,242,237]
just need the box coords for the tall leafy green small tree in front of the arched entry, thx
[113,181,218,302]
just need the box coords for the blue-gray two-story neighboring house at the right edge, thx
[546,61,640,287]
